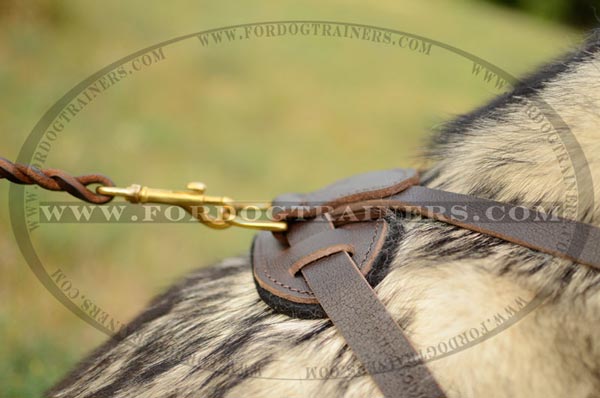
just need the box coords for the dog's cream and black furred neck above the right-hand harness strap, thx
[425,41,600,225]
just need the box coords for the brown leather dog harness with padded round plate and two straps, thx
[252,169,600,398]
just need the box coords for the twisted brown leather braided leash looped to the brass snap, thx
[0,157,115,205]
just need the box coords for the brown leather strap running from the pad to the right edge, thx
[332,186,600,269]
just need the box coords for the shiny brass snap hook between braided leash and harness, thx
[96,182,287,231]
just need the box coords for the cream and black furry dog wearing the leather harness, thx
[47,33,600,398]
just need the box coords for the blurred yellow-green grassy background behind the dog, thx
[0,0,582,397]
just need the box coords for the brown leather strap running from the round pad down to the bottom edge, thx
[288,218,445,398]
